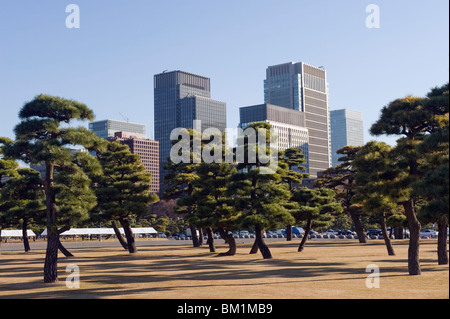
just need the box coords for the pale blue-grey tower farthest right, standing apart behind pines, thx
[330,109,364,167]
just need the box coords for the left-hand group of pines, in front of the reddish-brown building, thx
[0,95,158,283]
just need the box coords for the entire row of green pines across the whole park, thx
[0,84,448,282]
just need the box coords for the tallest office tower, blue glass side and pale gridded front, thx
[264,62,331,178]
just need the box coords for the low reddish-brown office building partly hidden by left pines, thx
[108,132,159,194]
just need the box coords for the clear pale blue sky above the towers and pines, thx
[0,0,449,144]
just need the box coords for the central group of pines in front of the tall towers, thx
[165,123,342,258]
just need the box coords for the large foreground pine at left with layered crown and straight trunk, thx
[3,94,99,283]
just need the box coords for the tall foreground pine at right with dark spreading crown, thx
[370,84,449,275]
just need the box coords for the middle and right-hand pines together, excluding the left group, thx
[165,84,449,275]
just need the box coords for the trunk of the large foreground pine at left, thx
[44,162,59,283]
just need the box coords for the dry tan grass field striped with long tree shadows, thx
[0,239,449,299]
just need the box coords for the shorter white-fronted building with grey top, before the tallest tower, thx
[239,104,309,173]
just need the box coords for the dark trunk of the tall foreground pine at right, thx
[402,200,421,276]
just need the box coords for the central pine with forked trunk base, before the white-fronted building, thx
[228,123,294,259]
